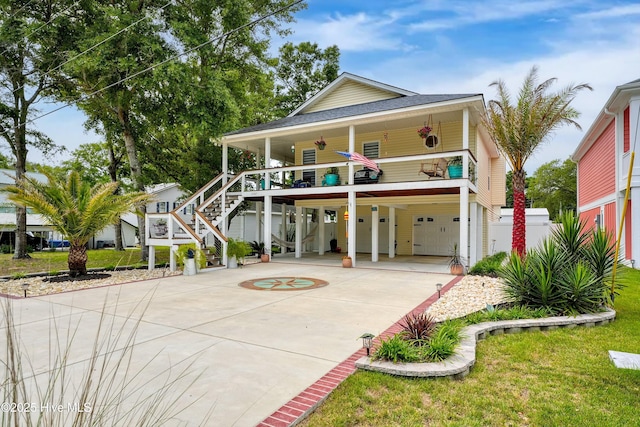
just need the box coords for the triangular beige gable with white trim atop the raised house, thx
[288,73,416,117]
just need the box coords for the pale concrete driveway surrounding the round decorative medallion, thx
[0,262,453,426]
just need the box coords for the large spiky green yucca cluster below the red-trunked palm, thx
[501,212,616,315]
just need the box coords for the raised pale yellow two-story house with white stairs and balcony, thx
[147,73,506,265]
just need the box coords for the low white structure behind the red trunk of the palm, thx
[489,208,554,254]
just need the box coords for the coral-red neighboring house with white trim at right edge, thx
[571,79,640,261]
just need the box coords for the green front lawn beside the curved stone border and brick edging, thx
[303,270,640,426]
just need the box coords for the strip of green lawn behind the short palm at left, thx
[0,247,169,276]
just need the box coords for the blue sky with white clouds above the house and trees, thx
[29,0,640,175]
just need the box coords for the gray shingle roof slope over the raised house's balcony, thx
[225,94,482,135]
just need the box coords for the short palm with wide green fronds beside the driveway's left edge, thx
[3,171,150,277]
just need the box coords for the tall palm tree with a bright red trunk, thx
[482,66,591,256]
